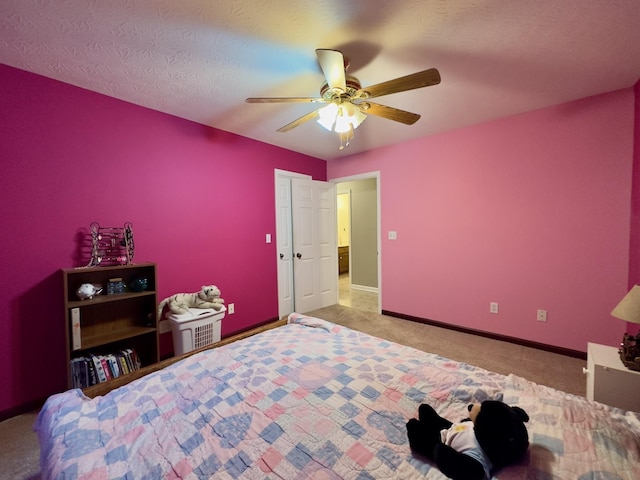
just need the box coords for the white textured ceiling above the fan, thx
[0,0,640,160]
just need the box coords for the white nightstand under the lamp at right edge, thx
[585,343,640,412]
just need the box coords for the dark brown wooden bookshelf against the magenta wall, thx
[62,263,159,388]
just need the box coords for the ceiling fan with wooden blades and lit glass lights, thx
[246,48,440,150]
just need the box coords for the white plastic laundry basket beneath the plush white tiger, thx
[169,305,227,355]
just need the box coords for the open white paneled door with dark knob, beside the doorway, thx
[291,178,338,313]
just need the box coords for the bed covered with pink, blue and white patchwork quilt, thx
[35,314,640,480]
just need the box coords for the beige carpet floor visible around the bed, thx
[0,305,586,480]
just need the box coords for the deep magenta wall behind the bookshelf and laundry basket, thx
[0,65,326,413]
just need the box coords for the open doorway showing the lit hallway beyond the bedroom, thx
[333,172,380,313]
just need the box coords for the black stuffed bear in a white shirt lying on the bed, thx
[407,400,529,480]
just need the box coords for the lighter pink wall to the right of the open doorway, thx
[327,89,634,352]
